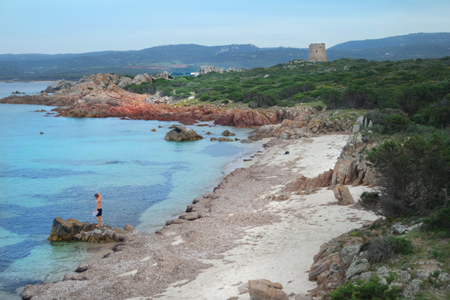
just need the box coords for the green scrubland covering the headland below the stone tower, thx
[123,57,450,118]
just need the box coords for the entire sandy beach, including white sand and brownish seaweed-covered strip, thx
[26,135,376,300]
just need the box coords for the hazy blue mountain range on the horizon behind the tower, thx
[0,33,450,80]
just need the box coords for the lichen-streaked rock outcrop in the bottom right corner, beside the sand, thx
[308,219,430,299]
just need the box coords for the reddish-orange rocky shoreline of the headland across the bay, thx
[0,74,351,129]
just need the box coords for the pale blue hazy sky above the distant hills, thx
[0,0,450,54]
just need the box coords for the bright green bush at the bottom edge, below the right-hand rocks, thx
[329,274,400,300]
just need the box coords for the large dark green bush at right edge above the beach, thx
[367,133,450,217]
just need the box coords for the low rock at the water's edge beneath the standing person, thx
[48,217,134,243]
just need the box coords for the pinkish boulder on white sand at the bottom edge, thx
[248,279,289,300]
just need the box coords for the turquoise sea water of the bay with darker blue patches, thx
[0,85,261,299]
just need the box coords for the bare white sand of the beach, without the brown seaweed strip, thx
[154,135,376,300]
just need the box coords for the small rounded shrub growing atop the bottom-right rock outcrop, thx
[367,236,414,263]
